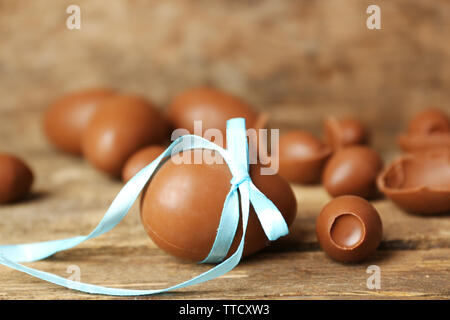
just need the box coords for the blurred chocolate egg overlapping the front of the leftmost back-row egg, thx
[82,94,167,177]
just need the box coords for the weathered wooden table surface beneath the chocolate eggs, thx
[0,113,450,299]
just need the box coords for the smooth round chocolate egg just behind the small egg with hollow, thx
[322,146,383,199]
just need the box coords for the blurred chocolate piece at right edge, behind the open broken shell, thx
[397,108,450,153]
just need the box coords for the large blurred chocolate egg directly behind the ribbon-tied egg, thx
[167,87,265,139]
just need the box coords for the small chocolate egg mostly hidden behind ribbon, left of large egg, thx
[122,145,166,182]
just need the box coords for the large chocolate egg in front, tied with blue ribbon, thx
[141,150,296,261]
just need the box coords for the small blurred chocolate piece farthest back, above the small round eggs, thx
[324,117,369,150]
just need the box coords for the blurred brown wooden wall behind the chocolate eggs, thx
[0,0,450,155]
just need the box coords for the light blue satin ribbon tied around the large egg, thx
[0,118,289,296]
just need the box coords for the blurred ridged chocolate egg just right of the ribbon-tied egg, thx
[278,130,331,184]
